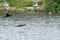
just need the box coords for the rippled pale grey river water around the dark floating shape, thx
[0,12,60,40]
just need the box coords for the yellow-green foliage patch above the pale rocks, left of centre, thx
[8,0,34,7]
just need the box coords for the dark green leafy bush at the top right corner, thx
[44,0,60,11]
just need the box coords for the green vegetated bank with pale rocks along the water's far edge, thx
[0,0,60,14]
